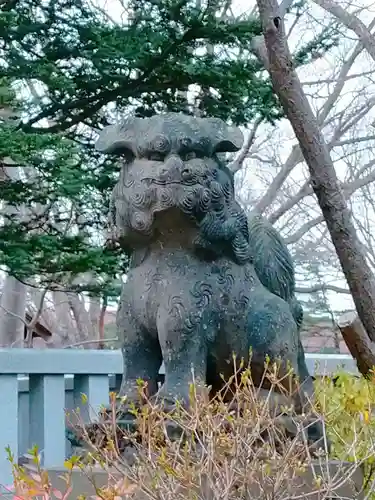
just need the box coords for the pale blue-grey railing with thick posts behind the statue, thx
[0,349,358,485]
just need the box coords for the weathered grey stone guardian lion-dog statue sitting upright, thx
[96,113,321,446]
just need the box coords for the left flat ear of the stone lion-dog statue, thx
[95,118,140,155]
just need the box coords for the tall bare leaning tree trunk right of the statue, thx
[257,0,375,348]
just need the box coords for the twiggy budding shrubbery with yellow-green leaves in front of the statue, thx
[6,368,375,500]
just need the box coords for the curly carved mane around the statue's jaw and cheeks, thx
[110,156,251,270]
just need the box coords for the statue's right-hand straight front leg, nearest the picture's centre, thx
[157,307,211,407]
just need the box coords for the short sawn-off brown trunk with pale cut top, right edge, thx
[337,311,375,377]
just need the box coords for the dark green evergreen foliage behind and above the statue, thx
[0,0,336,289]
